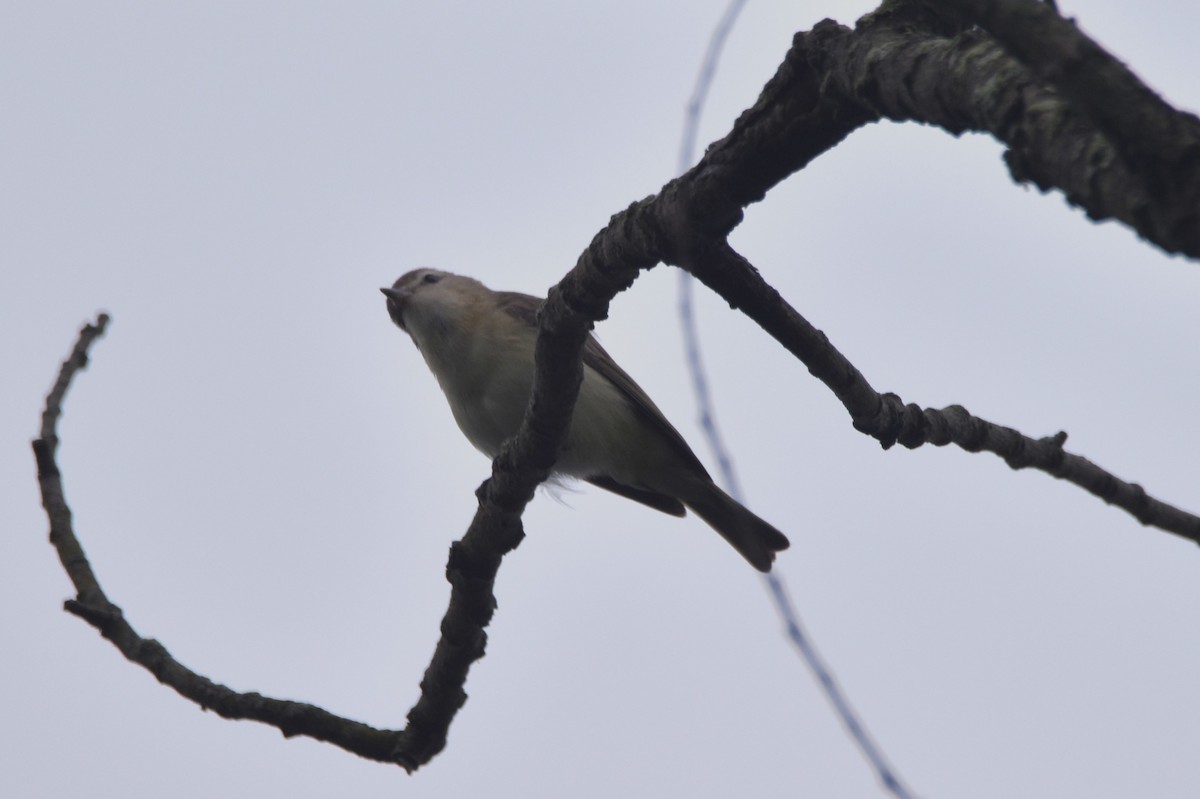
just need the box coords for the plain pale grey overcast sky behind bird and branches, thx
[0,0,1200,798]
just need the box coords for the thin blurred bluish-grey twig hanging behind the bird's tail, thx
[678,0,912,799]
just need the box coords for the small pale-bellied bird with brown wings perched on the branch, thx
[380,269,788,571]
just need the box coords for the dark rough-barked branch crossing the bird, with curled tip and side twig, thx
[34,0,1200,771]
